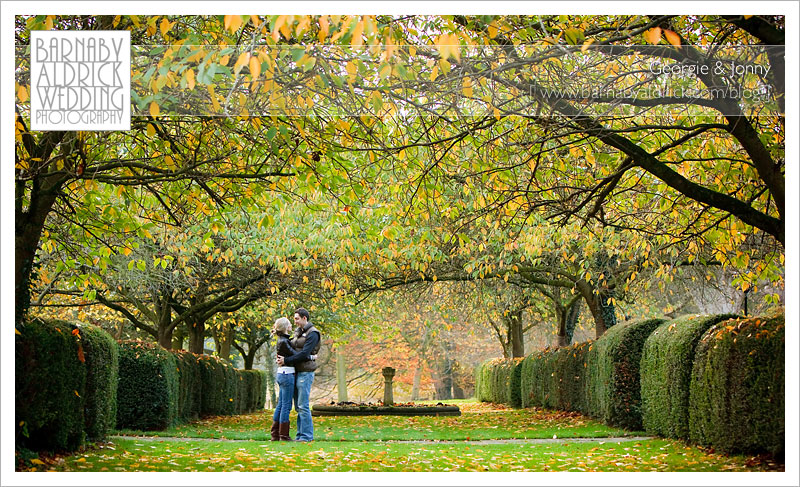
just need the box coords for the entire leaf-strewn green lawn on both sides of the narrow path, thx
[25,402,783,472]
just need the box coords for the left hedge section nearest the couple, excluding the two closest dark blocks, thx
[117,341,266,430]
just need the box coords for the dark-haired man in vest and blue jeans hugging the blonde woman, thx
[278,308,322,441]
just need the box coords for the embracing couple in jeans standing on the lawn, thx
[272,308,322,441]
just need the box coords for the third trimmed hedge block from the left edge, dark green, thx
[117,341,180,430]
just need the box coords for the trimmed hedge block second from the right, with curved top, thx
[640,314,735,439]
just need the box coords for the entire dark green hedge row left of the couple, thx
[15,320,267,451]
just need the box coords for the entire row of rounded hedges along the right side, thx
[476,315,785,457]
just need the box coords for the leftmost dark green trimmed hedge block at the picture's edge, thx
[14,320,87,451]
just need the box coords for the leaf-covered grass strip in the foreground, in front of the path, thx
[45,438,768,472]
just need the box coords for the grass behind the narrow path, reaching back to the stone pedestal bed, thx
[119,402,643,441]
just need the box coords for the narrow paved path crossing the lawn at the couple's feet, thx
[109,435,653,445]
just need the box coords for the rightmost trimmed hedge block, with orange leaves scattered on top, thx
[689,314,785,458]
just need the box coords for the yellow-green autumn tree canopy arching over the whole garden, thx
[15,15,786,354]
